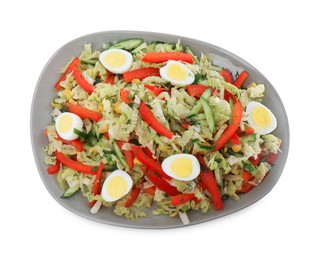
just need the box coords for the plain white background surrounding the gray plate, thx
[0,0,320,259]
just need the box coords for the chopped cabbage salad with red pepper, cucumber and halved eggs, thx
[44,38,281,224]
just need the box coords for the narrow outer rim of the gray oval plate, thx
[29,30,290,229]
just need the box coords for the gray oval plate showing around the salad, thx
[30,31,289,228]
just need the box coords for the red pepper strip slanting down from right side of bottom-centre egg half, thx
[197,156,223,210]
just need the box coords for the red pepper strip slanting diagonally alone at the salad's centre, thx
[139,101,174,139]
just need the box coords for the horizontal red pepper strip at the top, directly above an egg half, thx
[142,52,193,64]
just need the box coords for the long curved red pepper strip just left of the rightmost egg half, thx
[213,101,242,151]
